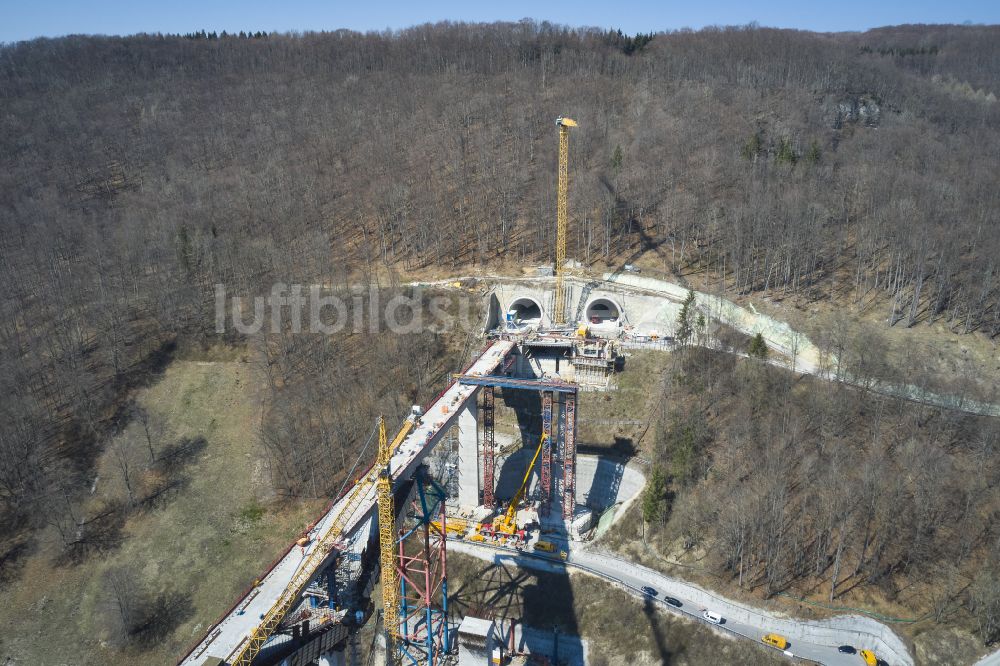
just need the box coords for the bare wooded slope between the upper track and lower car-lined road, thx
[626,347,1000,652]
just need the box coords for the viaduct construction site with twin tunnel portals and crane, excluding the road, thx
[180,117,658,666]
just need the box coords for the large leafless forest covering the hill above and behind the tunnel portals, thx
[0,22,1000,612]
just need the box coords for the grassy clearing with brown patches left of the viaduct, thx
[0,360,321,665]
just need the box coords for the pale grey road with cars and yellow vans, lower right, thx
[448,541,912,666]
